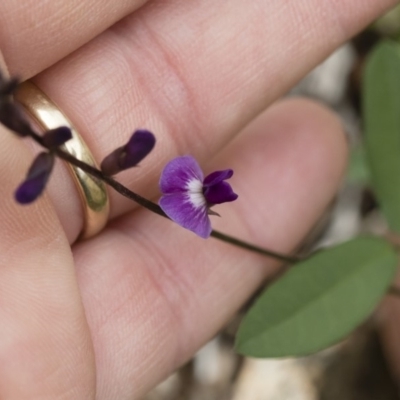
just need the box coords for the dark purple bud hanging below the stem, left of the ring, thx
[15,153,54,204]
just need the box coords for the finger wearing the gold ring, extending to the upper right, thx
[29,0,393,241]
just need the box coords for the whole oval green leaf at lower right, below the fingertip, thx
[236,237,397,357]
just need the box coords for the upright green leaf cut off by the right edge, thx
[363,41,400,233]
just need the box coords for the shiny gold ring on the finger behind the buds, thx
[14,81,110,239]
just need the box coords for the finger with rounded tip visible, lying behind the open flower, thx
[74,100,346,400]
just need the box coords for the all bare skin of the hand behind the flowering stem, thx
[0,0,397,400]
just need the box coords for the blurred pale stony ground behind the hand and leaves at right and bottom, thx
[143,6,400,400]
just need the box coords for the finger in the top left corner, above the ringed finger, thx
[0,0,146,78]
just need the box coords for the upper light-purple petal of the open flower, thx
[160,156,204,194]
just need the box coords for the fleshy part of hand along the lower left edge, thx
[0,127,95,400]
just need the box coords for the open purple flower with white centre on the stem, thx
[159,156,238,238]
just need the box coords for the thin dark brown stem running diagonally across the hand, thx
[31,132,301,264]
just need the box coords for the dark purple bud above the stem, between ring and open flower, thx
[101,129,156,175]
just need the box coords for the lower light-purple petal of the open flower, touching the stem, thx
[159,193,211,239]
